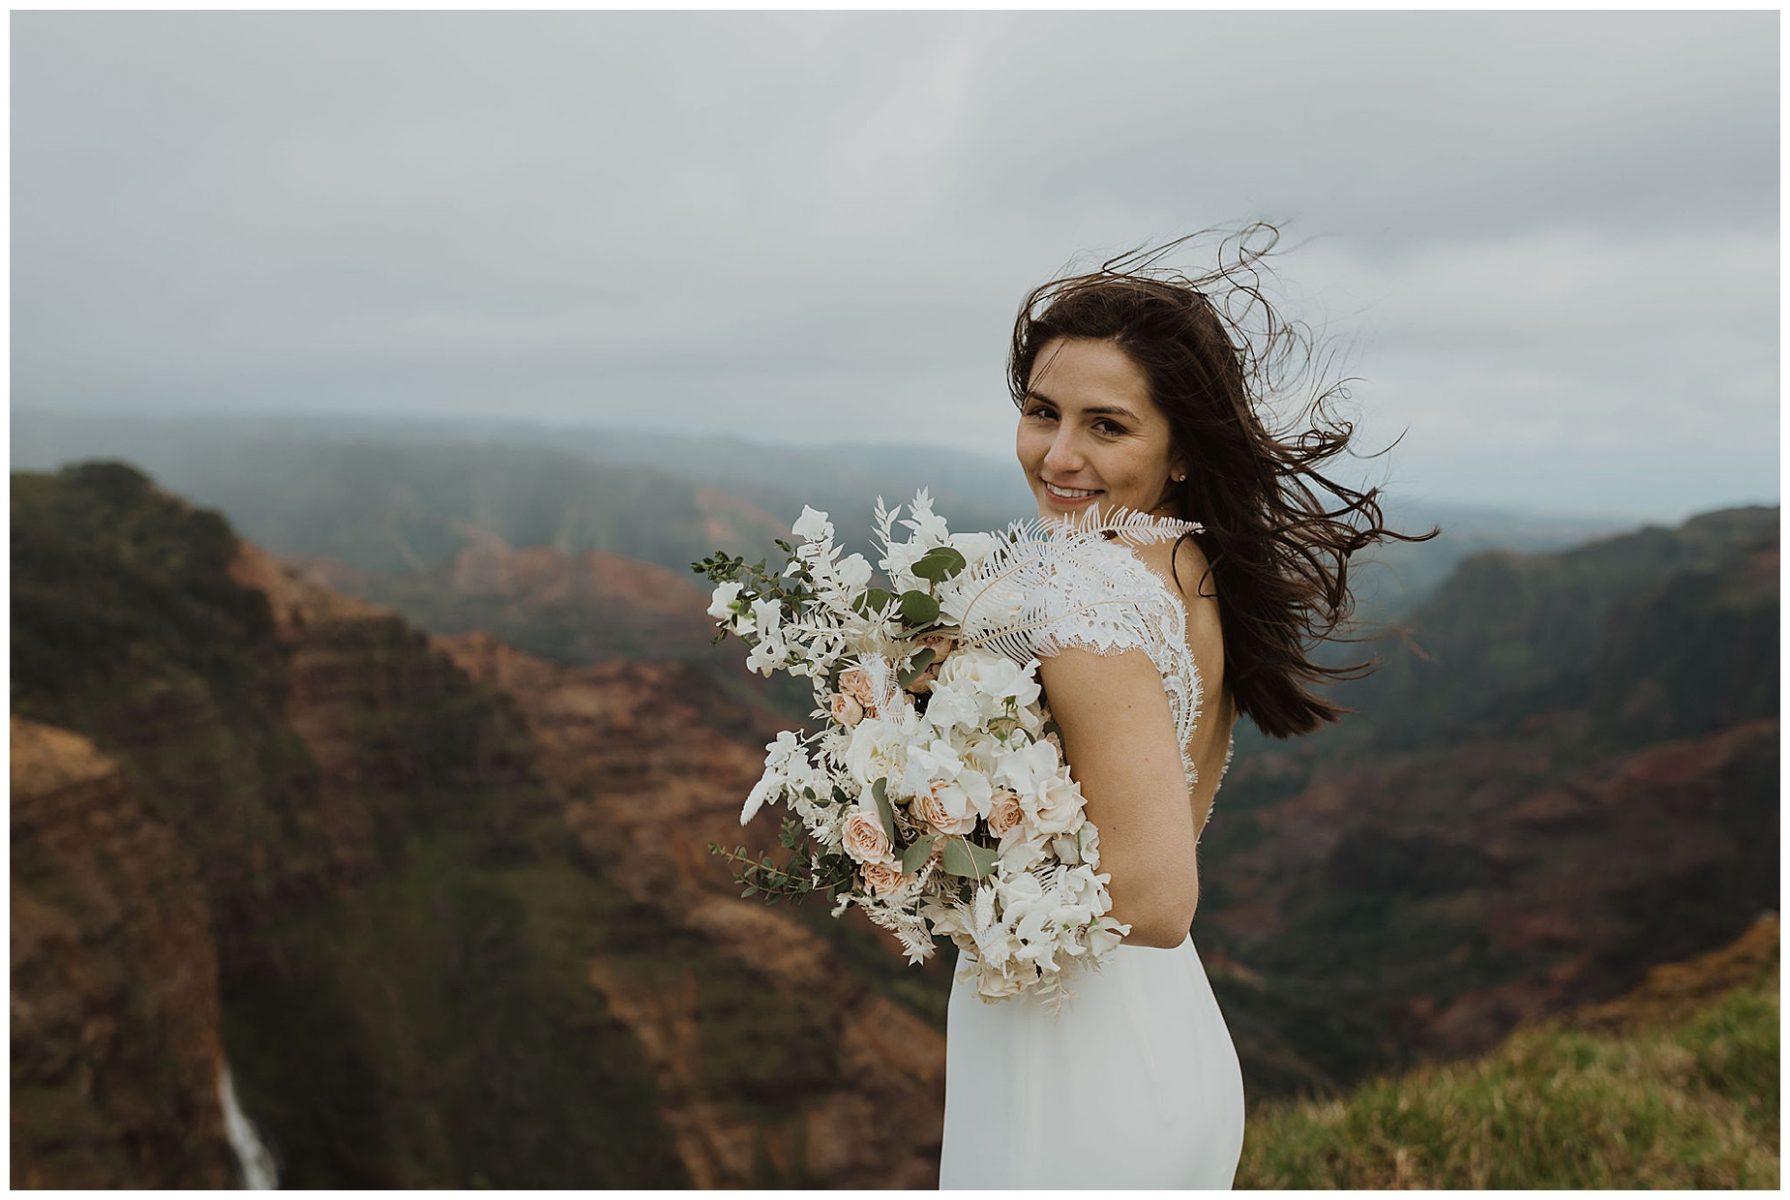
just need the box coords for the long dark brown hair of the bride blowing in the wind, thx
[1008,222,1441,738]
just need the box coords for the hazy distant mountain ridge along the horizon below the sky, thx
[13,408,1638,620]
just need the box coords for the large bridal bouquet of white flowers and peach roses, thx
[693,489,1155,1008]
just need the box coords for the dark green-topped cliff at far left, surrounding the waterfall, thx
[13,464,687,1187]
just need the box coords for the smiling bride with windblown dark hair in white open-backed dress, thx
[940,226,1434,1187]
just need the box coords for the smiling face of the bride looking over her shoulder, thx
[1015,337,1187,518]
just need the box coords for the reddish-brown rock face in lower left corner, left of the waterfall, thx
[11,716,238,1187]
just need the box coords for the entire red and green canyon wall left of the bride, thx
[13,464,949,1187]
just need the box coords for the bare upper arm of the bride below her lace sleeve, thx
[1038,647,1199,949]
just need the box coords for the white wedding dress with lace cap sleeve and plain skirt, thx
[938,543,1244,1189]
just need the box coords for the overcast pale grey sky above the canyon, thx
[11,11,1779,519]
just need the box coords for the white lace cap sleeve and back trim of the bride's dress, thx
[963,518,1235,835]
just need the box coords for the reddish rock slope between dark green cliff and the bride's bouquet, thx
[437,634,949,1187]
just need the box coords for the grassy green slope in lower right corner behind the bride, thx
[1237,953,1779,1189]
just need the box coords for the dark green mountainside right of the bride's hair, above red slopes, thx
[1303,505,1779,756]
